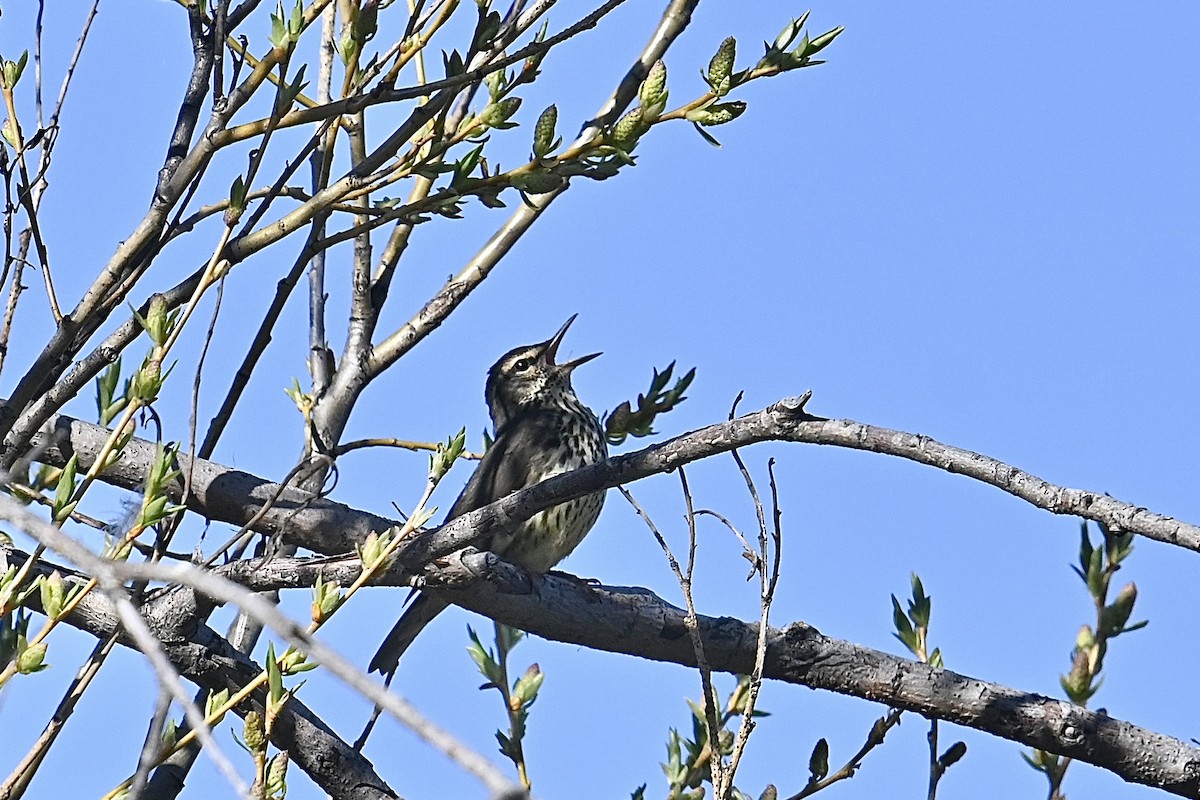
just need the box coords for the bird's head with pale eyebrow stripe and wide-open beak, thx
[486,314,600,432]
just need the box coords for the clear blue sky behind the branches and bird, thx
[0,0,1200,798]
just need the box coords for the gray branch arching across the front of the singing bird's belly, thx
[30,397,1200,570]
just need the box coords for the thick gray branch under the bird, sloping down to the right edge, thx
[105,551,1200,798]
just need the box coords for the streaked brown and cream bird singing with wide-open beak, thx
[371,314,608,676]
